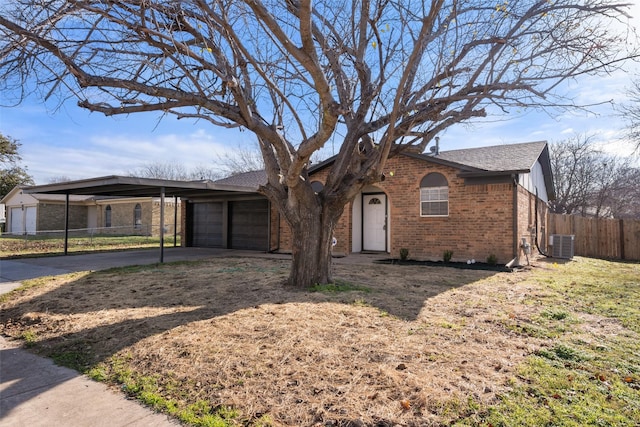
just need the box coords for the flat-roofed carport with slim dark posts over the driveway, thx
[23,175,268,262]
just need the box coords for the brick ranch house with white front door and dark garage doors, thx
[182,142,554,263]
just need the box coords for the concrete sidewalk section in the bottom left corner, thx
[0,337,180,427]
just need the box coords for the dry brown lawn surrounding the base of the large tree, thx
[0,258,549,426]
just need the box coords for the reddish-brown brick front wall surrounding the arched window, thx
[274,156,535,263]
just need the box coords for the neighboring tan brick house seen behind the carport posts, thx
[1,186,180,235]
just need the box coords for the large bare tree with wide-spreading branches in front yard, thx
[0,0,635,287]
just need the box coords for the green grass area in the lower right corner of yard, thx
[455,258,640,427]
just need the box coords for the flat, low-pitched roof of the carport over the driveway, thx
[23,175,258,198]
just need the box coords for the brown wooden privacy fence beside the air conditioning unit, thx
[548,214,640,261]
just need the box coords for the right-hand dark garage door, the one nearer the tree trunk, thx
[229,200,269,251]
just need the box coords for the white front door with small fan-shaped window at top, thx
[362,194,387,251]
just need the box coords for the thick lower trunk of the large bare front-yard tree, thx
[287,203,342,288]
